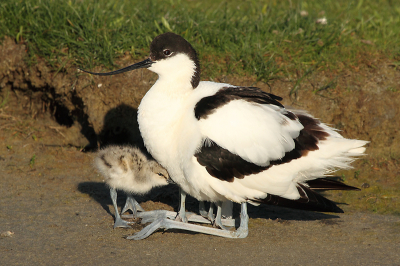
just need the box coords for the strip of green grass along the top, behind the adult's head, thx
[0,0,400,82]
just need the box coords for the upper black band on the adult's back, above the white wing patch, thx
[194,87,283,120]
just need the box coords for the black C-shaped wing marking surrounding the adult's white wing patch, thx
[195,87,329,182]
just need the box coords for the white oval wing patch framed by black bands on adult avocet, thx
[199,100,303,166]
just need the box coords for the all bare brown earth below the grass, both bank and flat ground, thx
[0,39,400,265]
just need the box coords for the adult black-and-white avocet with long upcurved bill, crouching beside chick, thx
[83,33,367,239]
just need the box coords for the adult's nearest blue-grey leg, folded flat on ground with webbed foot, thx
[127,202,249,240]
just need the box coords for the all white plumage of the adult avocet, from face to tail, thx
[138,54,367,203]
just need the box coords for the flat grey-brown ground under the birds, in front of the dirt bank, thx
[0,141,400,265]
